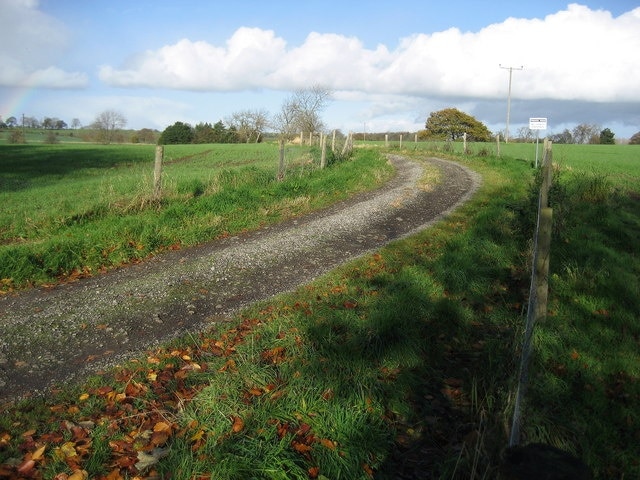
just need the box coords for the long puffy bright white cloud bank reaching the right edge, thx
[100,4,640,101]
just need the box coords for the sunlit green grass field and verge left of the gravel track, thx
[0,144,390,290]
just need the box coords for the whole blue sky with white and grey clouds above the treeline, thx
[0,0,640,139]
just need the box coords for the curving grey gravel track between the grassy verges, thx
[0,155,480,402]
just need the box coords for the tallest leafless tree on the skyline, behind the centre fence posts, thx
[273,85,332,140]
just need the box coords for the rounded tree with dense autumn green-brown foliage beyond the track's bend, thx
[425,108,491,142]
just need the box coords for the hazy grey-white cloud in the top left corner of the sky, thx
[0,0,88,88]
